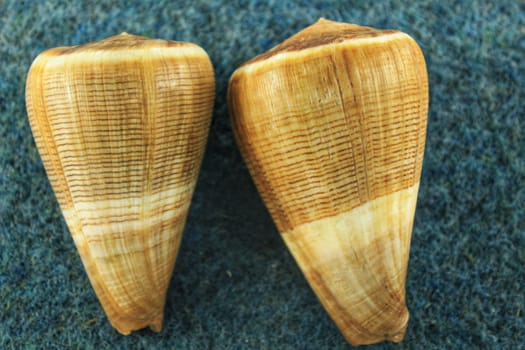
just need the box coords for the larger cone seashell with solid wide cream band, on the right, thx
[228,19,428,345]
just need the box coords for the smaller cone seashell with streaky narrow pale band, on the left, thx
[26,33,215,334]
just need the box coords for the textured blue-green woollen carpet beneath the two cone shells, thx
[0,0,525,349]
